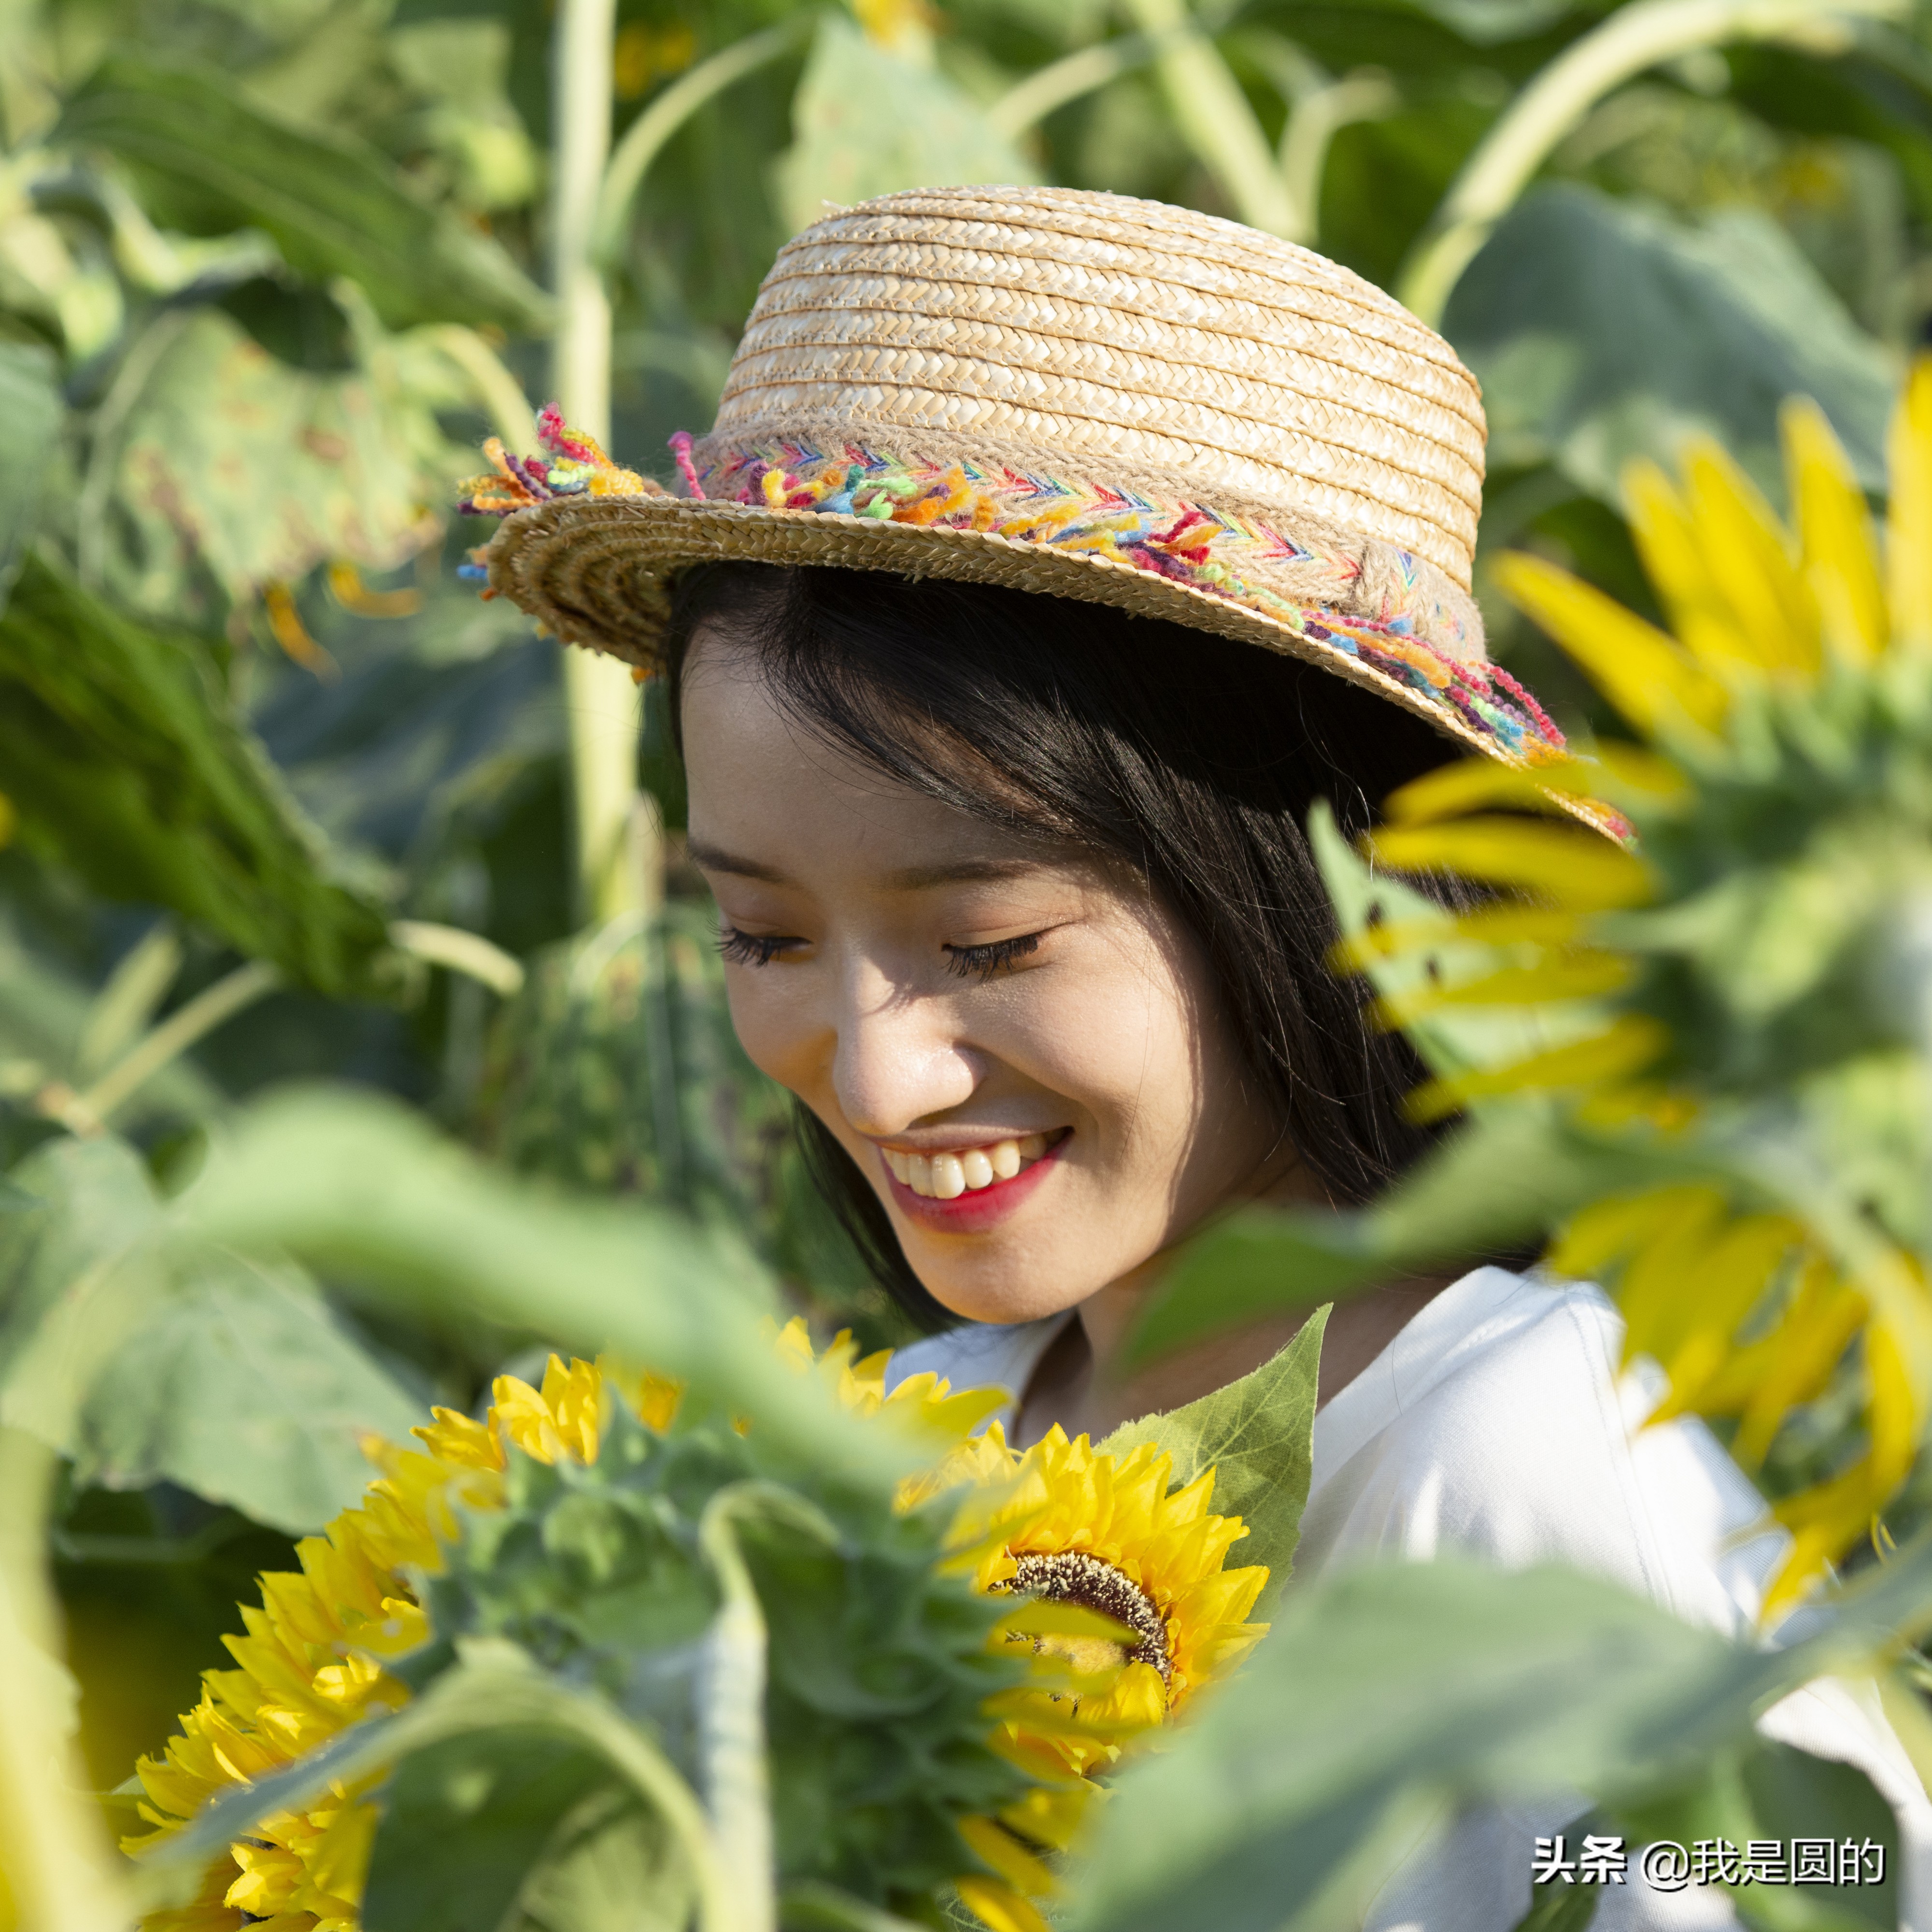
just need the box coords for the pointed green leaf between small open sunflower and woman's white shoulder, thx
[1099,1308,1329,1615]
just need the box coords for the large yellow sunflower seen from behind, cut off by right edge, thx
[1345,363,1932,1613]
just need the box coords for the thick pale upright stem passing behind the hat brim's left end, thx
[551,0,641,920]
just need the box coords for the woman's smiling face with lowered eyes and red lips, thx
[682,632,1273,1321]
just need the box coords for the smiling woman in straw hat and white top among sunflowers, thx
[468,189,1924,1932]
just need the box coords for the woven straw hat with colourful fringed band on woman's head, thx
[466,187,1563,763]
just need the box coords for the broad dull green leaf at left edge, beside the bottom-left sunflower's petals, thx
[0,1138,421,1530]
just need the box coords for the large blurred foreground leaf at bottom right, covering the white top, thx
[1072,1561,1926,1932]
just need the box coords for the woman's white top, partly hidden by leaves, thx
[889,1267,1932,1932]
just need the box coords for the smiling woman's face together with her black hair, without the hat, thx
[668,564,1441,1391]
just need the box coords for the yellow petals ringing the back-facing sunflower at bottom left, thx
[124,1320,1119,1932]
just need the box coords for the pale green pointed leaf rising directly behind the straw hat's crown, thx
[777,12,1039,232]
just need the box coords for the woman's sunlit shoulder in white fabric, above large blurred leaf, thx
[1302,1267,1783,1631]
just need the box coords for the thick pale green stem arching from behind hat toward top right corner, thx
[1395,0,1905,325]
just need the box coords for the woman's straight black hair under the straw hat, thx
[668,562,1453,1327]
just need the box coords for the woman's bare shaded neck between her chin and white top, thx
[1012,1260,1455,1447]
